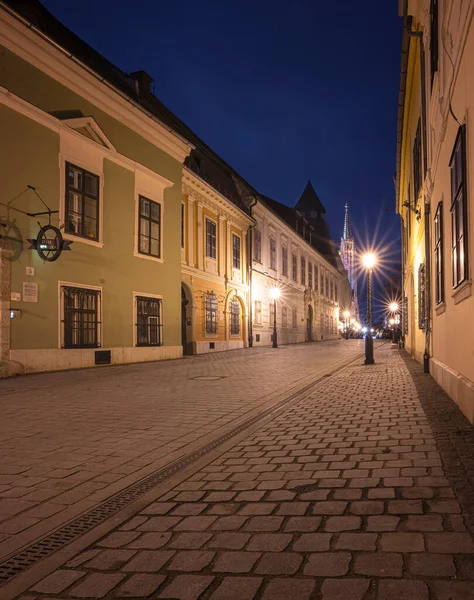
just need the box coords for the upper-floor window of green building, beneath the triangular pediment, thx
[64,163,99,241]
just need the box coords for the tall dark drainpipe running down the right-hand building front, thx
[408,25,431,373]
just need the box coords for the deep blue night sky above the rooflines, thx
[43,0,402,318]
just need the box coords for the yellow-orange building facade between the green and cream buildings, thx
[181,167,252,354]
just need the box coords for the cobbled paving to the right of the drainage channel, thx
[4,344,474,600]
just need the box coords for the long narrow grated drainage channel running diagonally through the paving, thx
[0,346,363,597]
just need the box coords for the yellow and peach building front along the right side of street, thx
[396,0,474,422]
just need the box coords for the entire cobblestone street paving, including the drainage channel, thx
[0,341,474,600]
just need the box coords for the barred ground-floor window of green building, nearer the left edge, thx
[61,286,101,348]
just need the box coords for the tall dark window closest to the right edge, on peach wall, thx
[450,126,468,287]
